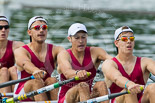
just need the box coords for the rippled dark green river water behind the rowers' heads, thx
[0,1,155,81]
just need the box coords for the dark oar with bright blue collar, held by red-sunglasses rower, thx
[0,75,34,88]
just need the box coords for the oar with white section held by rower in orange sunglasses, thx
[79,87,143,103]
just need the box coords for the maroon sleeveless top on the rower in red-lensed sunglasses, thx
[21,44,54,80]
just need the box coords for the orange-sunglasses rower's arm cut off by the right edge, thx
[142,57,155,75]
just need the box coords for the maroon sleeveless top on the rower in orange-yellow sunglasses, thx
[110,57,145,103]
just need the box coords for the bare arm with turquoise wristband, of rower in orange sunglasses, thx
[102,59,135,88]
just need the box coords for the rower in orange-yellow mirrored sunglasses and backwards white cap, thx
[102,26,155,103]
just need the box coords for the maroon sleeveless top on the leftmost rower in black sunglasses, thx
[0,40,15,68]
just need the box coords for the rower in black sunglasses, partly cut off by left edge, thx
[0,16,24,93]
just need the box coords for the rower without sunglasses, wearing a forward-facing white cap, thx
[58,23,112,103]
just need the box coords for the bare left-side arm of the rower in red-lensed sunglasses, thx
[14,47,46,78]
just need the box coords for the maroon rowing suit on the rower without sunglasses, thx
[58,47,96,103]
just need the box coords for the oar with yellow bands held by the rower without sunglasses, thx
[6,72,90,103]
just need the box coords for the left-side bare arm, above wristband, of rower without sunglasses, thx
[58,50,76,79]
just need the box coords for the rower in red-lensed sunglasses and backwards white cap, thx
[15,16,65,101]
